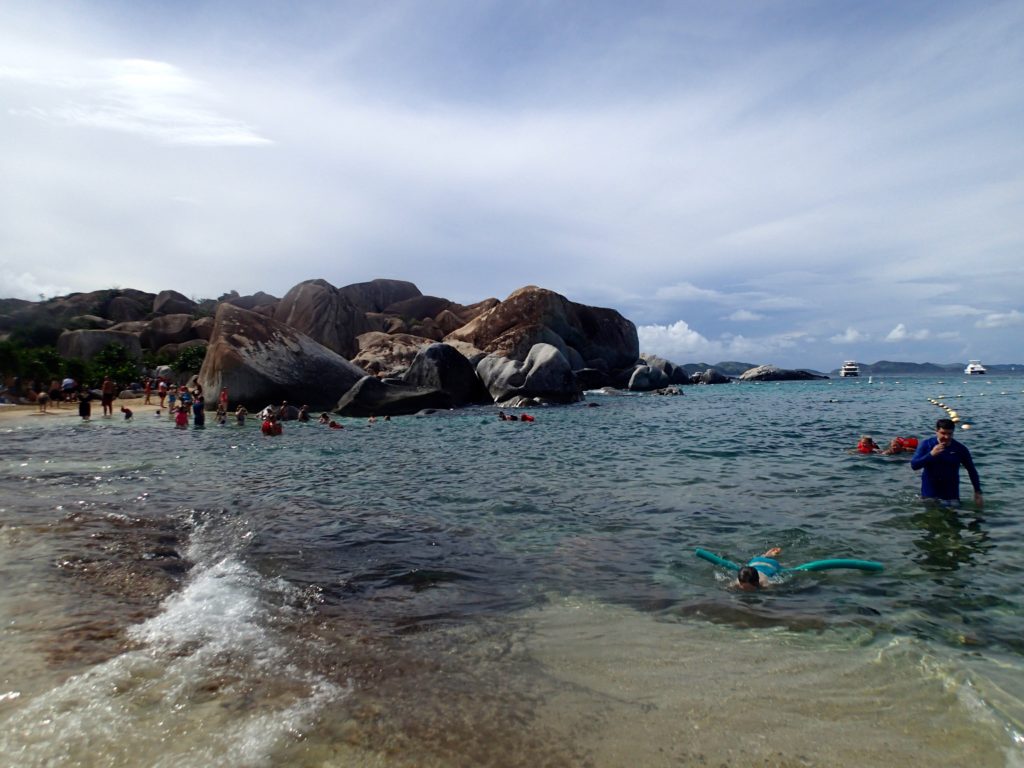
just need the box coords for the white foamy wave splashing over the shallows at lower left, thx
[0,557,348,768]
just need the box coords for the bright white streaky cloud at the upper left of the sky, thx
[0,58,270,146]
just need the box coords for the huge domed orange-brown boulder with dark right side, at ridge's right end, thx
[445,286,639,369]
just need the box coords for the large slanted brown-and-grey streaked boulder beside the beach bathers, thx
[199,304,366,410]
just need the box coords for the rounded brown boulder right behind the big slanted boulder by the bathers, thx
[273,280,372,357]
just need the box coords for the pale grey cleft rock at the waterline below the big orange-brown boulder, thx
[476,344,582,403]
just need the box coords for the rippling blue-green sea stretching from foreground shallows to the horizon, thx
[0,375,1024,768]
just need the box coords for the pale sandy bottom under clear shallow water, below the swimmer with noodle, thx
[516,604,1024,767]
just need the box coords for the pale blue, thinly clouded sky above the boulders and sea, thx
[0,0,1024,371]
